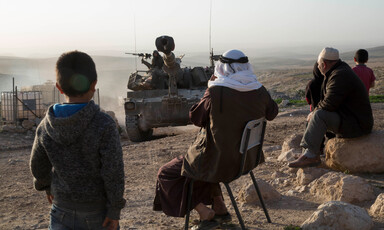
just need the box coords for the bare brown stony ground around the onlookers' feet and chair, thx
[0,104,384,229]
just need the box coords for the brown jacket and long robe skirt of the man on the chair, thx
[154,86,278,217]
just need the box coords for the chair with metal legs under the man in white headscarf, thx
[184,117,272,230]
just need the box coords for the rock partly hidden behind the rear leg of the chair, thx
[239,179,281,205]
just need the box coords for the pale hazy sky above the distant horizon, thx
[0,0,384,57]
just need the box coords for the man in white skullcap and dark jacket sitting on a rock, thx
[288,47,373,168]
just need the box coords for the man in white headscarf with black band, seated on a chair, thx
[154,46,278,229]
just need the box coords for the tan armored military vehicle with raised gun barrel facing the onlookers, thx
[124,36,213,142]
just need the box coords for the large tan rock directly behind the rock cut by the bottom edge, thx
[308,172,376,203]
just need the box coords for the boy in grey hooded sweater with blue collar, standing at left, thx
[30,51,125,230]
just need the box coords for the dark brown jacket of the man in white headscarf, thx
[182,86,278,183]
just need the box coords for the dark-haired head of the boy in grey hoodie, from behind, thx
[56,50,97,97]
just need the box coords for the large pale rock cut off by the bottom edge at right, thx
[301,201,373,230]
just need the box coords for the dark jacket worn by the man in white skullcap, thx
[316,60,373,138]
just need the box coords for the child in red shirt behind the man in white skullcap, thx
[352,49,376,95]
